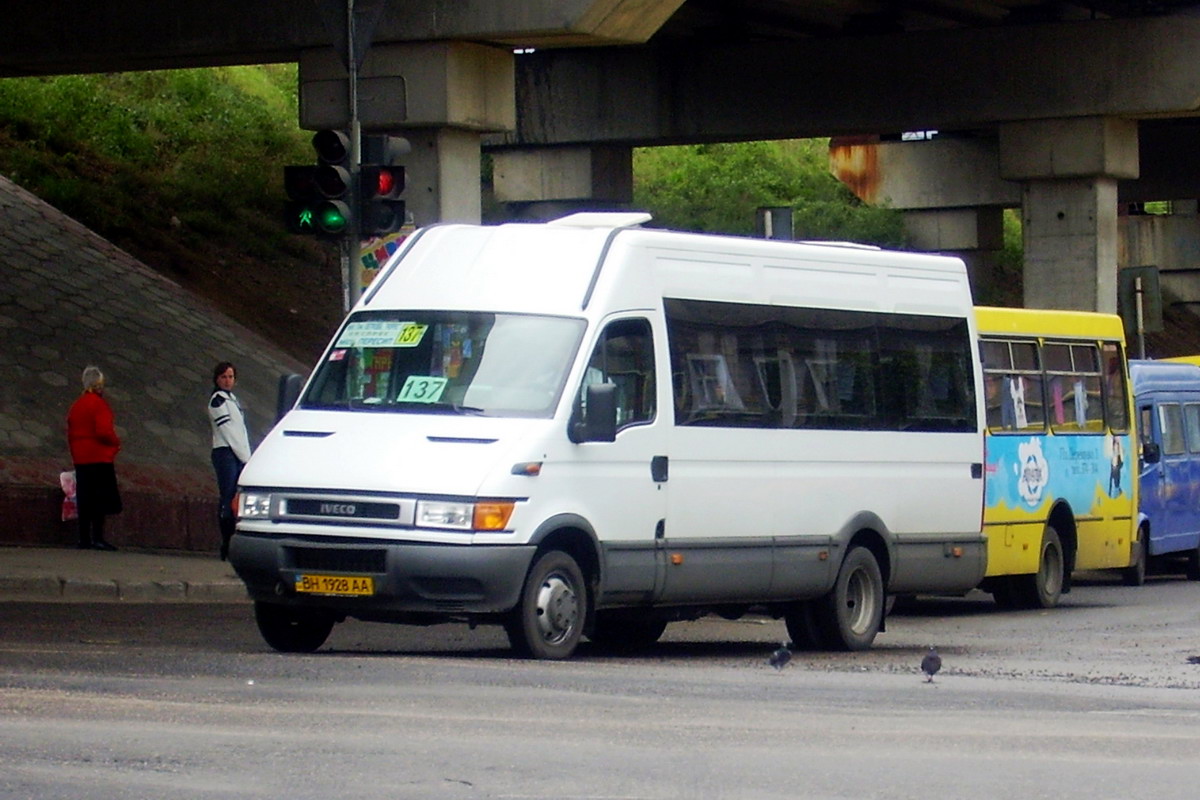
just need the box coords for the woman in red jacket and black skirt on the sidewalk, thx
[67,366,121,551]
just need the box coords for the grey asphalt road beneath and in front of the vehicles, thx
[0,579,1200,800]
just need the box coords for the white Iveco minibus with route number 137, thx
[229,212,986,658]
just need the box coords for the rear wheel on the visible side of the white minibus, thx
[812,547,887,650]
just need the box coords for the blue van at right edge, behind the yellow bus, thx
[1126,360,1200,584]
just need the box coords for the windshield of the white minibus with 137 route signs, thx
[300,311,584,417]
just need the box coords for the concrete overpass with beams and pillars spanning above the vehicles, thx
[7,0,1200,311]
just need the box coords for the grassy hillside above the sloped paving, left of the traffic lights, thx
[0,66,342,361]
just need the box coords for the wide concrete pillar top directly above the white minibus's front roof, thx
[492,145,634,219]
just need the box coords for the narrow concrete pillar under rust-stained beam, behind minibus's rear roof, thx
[904,206,1004,305]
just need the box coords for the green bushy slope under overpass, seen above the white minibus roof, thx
[634,139,905,247]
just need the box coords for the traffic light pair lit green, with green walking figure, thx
[283,131,353,239]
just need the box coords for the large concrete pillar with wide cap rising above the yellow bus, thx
[1000,118,1138,313]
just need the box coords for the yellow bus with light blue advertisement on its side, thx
[976,307,1145,608]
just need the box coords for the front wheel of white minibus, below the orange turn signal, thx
[504,551,588,658]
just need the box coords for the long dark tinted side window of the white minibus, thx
[664,297,974,432]
